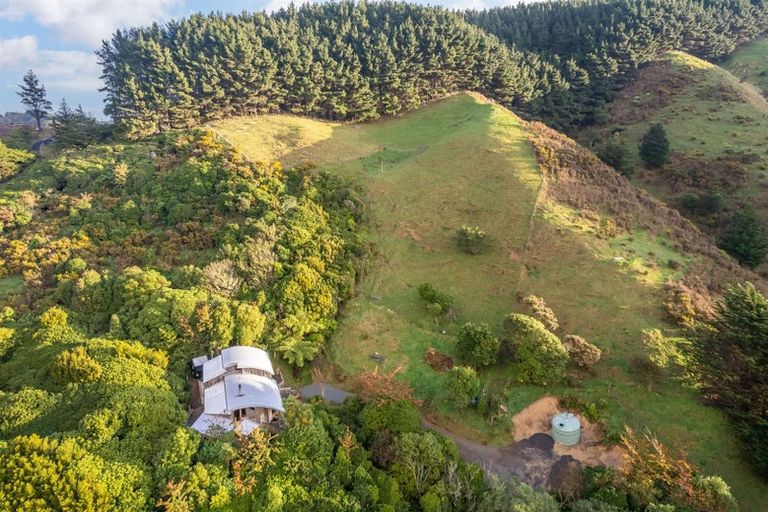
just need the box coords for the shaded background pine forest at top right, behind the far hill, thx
[465,0,768,127]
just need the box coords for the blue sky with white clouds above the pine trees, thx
[0,0,515,117]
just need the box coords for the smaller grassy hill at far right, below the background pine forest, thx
[579,51,768,246]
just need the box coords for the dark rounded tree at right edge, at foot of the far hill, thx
[720,207,768,268]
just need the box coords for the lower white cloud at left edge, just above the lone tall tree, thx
[0,36,101,92]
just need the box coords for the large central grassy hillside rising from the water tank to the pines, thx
[213,94,768,510]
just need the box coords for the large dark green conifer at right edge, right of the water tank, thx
[692,283,768,478]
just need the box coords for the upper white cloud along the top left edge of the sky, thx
[0,0,184,47]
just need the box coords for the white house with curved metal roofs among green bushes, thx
[189,346,284,434]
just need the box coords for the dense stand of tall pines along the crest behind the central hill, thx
[98,2,565,134]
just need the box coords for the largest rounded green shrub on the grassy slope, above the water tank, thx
[503,313,568,385]
